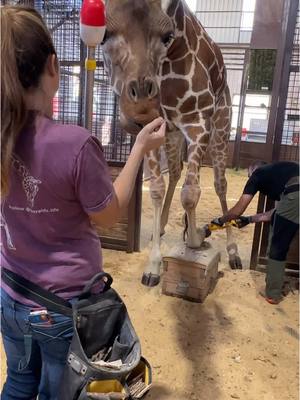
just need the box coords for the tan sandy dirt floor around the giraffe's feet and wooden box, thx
[2,168,299,400]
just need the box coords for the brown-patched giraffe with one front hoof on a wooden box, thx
[102,0,241,286]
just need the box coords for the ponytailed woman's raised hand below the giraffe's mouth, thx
[135,117,166,153]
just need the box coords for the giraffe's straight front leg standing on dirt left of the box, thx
[142,150,165,286]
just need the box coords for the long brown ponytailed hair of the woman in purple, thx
[1,6,56,196]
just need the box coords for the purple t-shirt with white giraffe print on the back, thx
[1,117,113,304]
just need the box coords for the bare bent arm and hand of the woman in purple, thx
[89,118,166,227]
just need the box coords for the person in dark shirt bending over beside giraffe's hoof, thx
[212,161,299,304]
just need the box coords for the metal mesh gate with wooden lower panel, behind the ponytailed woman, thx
[1,0,142,252]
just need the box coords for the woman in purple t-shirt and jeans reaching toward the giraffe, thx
[1,6,165,400]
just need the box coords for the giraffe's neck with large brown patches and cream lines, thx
[158,0,226,126]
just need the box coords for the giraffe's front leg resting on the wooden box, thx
[181,123,209,249]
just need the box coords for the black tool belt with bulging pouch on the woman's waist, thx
[1,268,152,400]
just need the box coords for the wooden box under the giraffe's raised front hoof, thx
[162,243,220,303]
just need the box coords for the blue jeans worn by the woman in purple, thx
[1,289,73,400]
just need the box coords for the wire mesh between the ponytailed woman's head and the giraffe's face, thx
[1,0,132,163]
